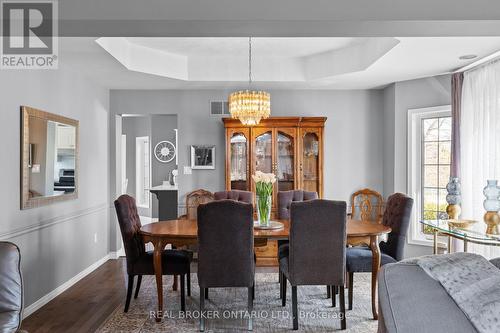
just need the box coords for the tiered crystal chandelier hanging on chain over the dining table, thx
[229,37,271,126]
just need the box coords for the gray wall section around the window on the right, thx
[384,75,451,257]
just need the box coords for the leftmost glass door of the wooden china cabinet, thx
[229,130,250,191]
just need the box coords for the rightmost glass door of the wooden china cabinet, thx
[300,129,321,195]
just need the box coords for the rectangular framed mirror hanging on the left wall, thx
[21,106,78,209]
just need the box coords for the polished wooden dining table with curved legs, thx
[140,219,391,321]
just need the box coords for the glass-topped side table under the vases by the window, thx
[420,220,500,254]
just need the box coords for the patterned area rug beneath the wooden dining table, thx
[96,273,377,333]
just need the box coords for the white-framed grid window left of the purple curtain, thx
[408,106,452,244]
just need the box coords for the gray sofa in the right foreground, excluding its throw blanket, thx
[378,263,477,333]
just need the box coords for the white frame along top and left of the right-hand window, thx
[407,105,451,246]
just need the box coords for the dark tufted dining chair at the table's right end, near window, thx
[346,193,413,310]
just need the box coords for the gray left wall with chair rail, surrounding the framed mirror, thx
[0,69,110,306]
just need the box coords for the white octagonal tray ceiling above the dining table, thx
[60,37,500,89]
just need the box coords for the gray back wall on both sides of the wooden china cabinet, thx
[110,90,384,236]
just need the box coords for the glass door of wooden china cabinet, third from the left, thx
[275,129,295,191]
